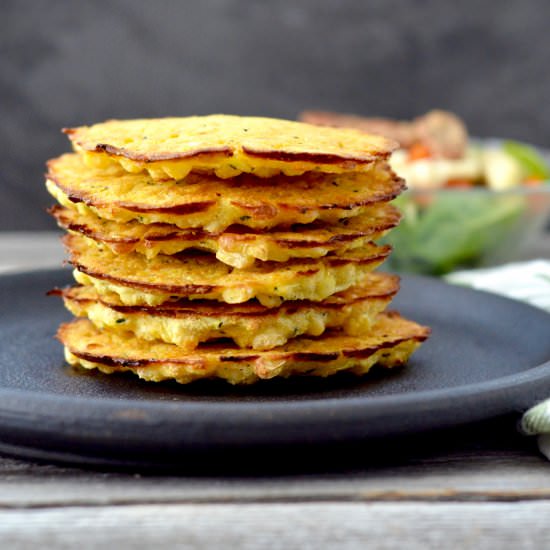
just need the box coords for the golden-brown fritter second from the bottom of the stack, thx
[60,273,399,350]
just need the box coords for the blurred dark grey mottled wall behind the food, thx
[0,0,550,230]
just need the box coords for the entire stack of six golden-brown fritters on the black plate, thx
[47,115,429,384]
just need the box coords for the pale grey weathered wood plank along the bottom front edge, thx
[0,502,550,550]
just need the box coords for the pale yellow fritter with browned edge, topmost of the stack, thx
[65,115,397,179]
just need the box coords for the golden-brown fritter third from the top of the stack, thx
[50,203,400,269]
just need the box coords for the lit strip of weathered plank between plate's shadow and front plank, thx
[0,457,550,508]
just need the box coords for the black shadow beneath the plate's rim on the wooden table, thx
[3,414,540,477]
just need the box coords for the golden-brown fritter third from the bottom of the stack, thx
[64,235,391,307]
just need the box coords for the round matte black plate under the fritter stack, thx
[0,270,550,465]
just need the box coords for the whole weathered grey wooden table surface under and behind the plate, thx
[0,233,550,549]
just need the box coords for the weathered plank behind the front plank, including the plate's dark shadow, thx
[0,419,550,508]
